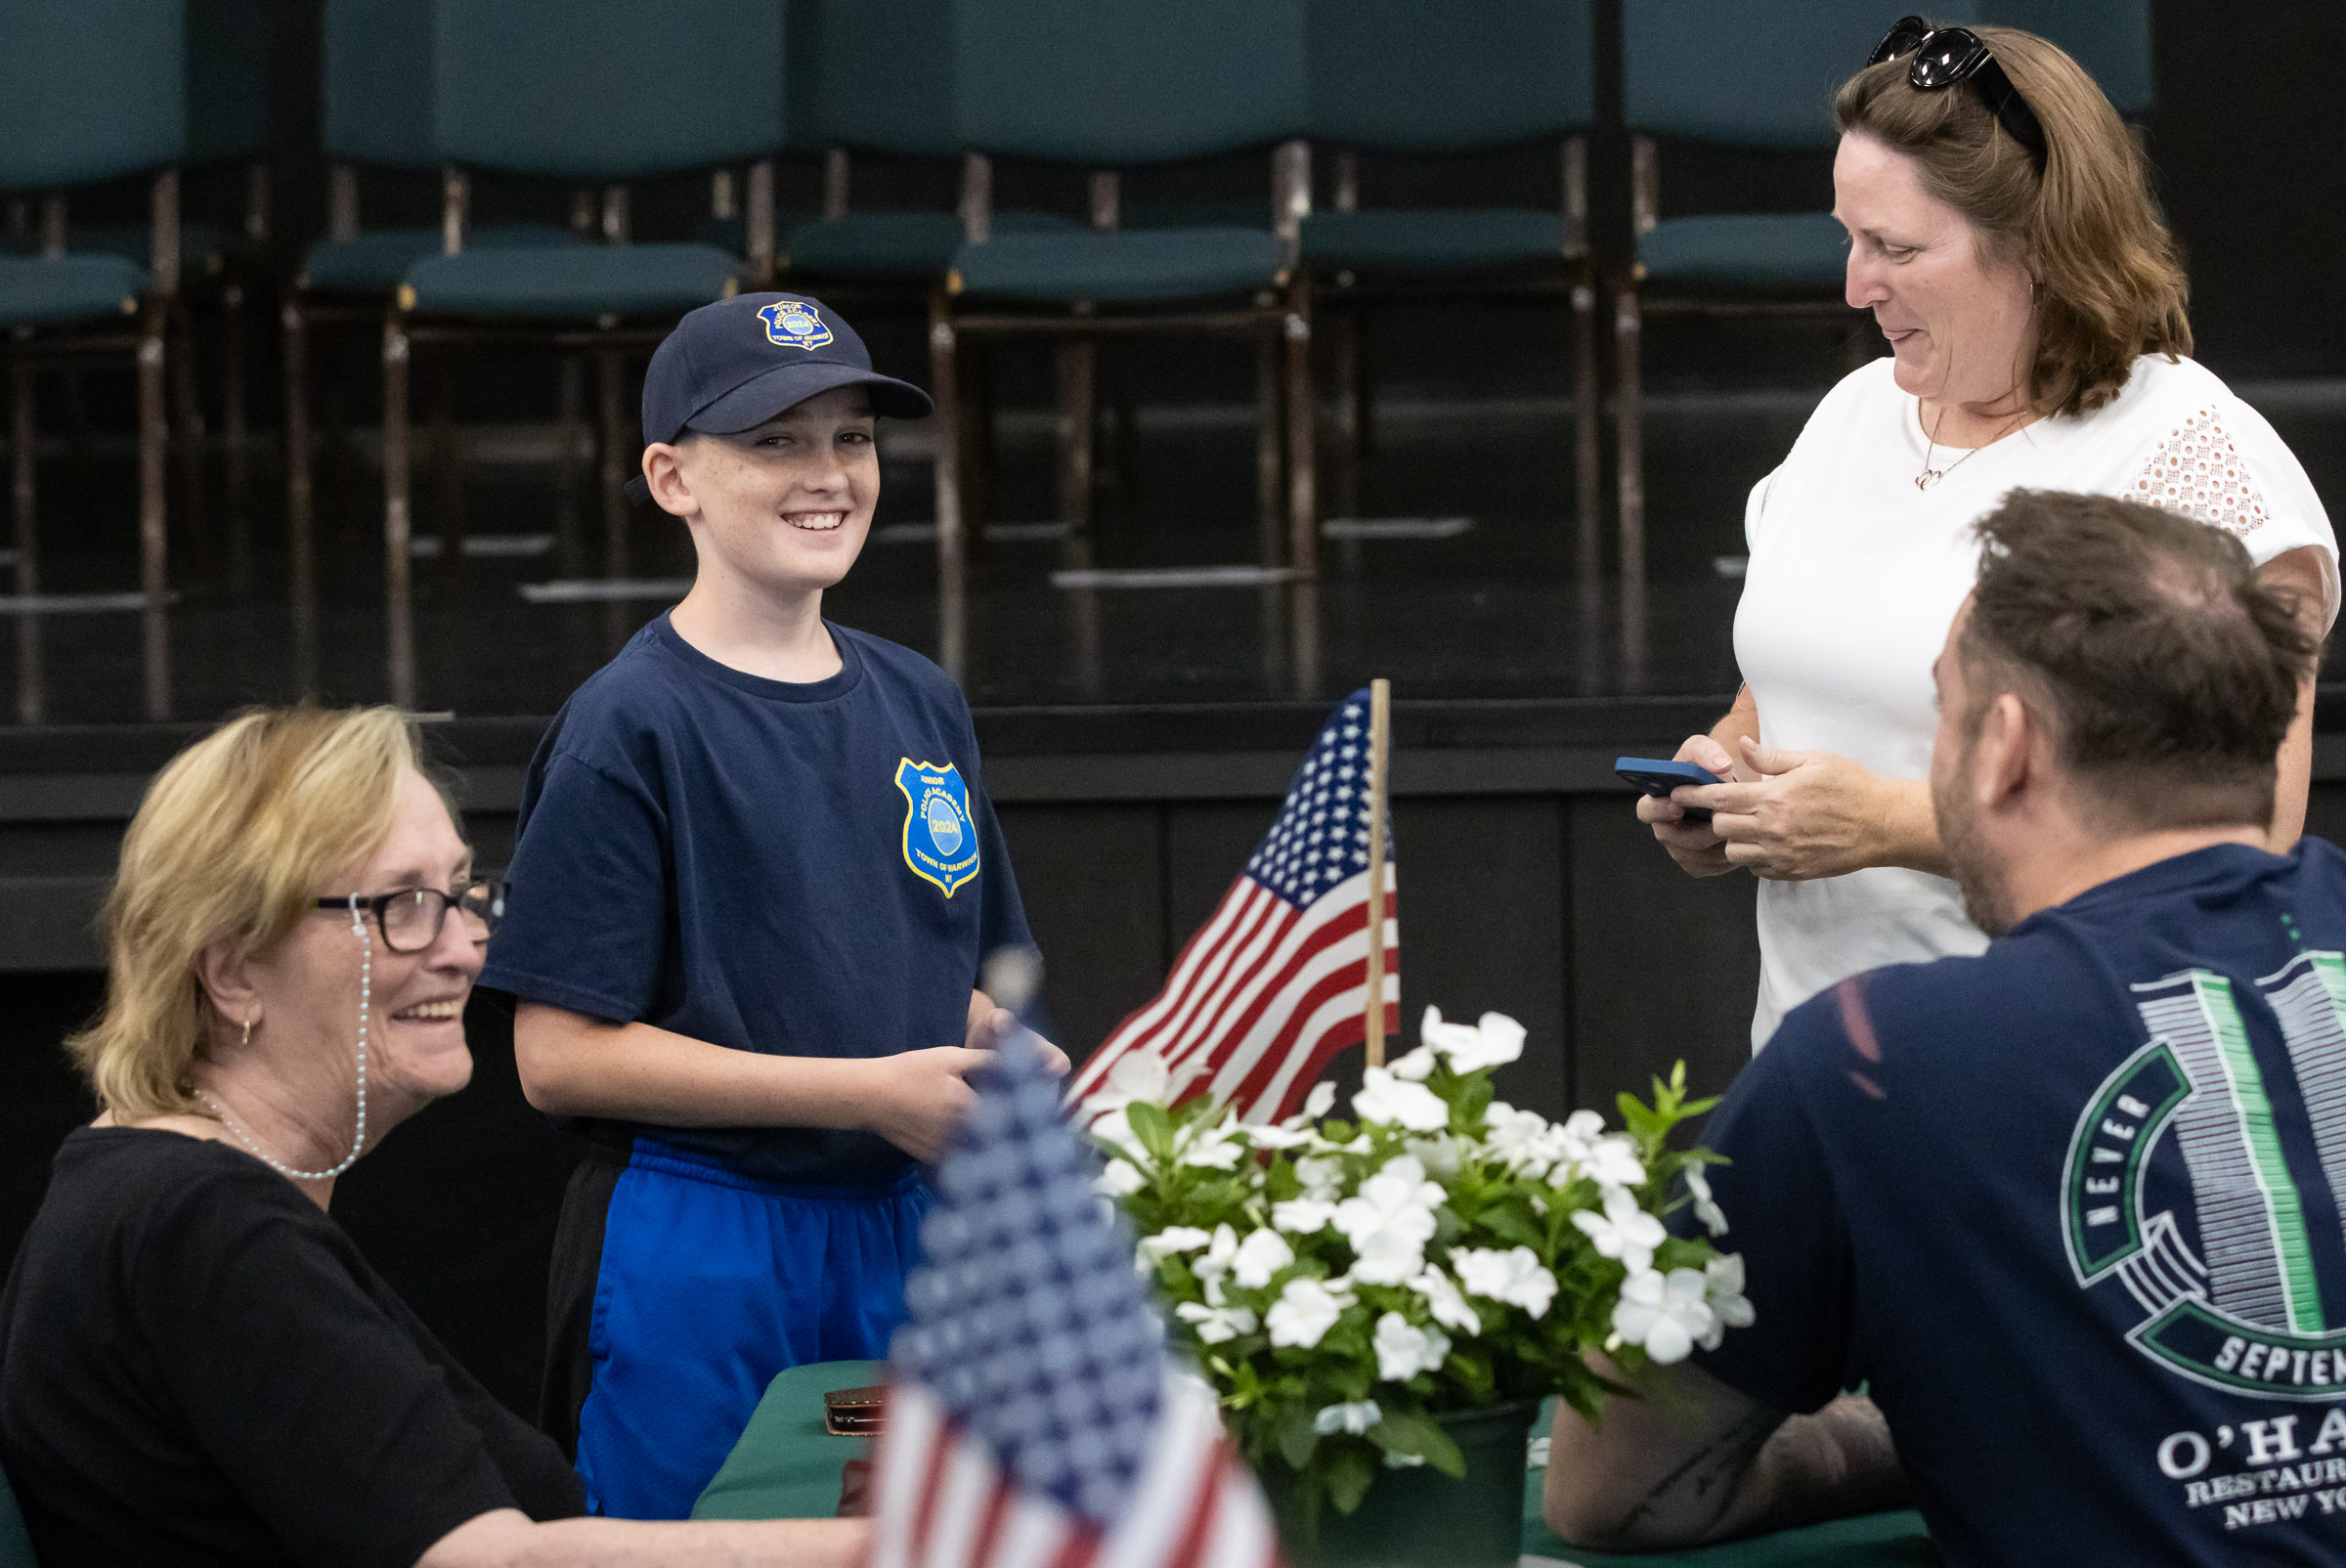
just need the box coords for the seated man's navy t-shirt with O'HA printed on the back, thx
[1699,838,2346,1568]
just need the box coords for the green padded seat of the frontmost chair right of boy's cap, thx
[952,228,1279,303]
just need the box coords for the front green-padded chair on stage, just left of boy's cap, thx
[382,0,784,702]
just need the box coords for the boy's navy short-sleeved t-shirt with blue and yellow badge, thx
[481,615,1027,1186]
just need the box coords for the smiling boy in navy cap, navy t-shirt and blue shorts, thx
[481,293,1064,1519]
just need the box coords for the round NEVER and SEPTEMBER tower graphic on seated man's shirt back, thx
[2063,953,2346,1408]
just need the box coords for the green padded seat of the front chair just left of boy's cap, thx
[401,244,739,317]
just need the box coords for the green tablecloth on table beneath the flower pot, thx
[692,1362,1937,1568]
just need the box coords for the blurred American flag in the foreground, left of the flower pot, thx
[868,1030,1279,1568]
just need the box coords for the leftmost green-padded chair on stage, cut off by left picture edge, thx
[0,0,186,723]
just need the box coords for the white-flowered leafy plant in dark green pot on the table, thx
[1084,1007,1753,1563]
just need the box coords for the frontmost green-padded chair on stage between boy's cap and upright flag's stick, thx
[929,0,1319,610]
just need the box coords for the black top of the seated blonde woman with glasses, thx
[0,1127,586,1568]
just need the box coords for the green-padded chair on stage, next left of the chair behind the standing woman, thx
[1302,0,1600,563]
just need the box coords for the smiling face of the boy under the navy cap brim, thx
[643,387,880,598]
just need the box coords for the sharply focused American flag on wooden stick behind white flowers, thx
[1069,690,1401,1122]
